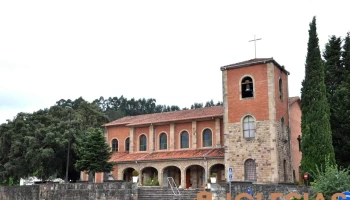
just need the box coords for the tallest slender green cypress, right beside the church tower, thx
[301,17,335,177]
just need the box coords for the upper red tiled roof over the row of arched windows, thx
[103,106,224,126]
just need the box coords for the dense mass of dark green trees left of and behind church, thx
[0,96,222,185]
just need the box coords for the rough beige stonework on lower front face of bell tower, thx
[225,120,277,183]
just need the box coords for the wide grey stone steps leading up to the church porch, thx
[138,187,204,200]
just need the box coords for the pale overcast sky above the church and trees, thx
[0,0,350,123]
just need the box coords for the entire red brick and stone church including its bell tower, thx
[81,58,301,188]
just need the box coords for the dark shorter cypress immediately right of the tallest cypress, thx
[323,35,346,166]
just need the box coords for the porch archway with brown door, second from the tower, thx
[186,165,206,188]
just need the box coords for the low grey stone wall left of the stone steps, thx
[0,182,137,200]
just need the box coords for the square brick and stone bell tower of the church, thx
[221,58,293,183]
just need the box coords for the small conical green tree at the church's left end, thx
[74,128,113,183]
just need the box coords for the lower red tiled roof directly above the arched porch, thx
[109,148,224,163]
